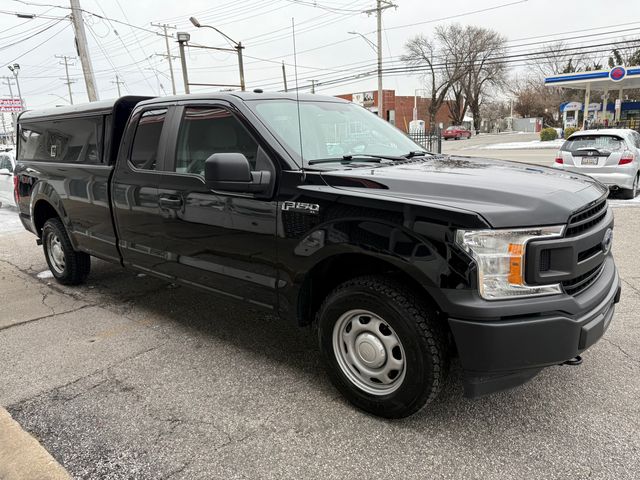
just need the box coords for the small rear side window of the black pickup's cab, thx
[130,108,167,170]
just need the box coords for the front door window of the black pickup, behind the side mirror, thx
[175,107,258,176]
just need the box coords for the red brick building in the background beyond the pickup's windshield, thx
[336,90,458,132]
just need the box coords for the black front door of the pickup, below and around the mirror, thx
[151,103,277,308]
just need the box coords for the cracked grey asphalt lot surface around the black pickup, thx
[0,197,640,479]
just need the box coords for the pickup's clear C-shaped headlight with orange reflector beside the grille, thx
[456,225,564,300]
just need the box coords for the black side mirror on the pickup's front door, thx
[204,153,271,193]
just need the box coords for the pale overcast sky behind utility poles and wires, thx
[0,0,640,108]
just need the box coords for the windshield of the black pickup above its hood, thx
[247,99,423,165]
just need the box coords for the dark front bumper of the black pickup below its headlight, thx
[449,256,620,397]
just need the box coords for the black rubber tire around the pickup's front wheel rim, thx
[317,276,450,418]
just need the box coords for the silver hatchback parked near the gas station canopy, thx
[553,129,640,199]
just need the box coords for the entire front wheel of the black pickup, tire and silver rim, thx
[318,276,449,418]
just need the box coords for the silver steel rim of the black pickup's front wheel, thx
[333,309,407,396]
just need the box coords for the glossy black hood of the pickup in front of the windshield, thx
[322,156,607,228]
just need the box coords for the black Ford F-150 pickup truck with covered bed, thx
[15,91,620,417]
